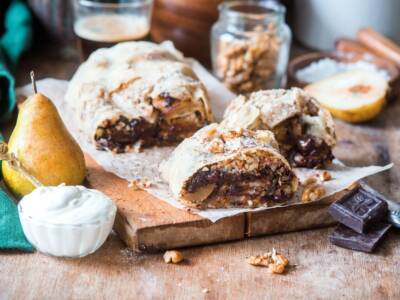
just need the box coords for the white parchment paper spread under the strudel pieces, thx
[17,43,393,222]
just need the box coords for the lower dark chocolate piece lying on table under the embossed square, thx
[329,223,392,252]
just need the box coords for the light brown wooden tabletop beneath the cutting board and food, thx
[0,43,400,299]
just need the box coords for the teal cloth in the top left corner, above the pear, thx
[0,0,33,122]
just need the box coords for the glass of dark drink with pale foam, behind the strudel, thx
[74,0,153,61]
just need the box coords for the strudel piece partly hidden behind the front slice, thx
[222,88,336,168]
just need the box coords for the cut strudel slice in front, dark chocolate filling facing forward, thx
[160,124,298,208]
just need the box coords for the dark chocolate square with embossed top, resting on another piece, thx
[329,186,388,233]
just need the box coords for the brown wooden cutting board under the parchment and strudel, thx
[86,156,351,252]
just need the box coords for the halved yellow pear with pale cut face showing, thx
[305,70,389,123]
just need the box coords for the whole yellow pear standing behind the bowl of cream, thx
[2,93,86,196]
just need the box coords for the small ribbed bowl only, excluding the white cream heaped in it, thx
[18,198,117,257]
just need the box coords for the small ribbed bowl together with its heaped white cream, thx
[18,185,117,257]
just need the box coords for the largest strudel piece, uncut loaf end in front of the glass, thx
[66,42,212,153]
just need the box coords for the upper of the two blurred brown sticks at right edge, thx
[357,28,400,67]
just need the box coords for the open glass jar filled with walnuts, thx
[211,0,292,93]
